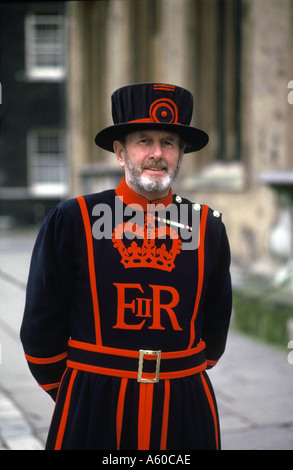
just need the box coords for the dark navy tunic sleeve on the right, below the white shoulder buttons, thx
[202,223,232,368]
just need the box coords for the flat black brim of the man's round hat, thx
[95,122,209,153]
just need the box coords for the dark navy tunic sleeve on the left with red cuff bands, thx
[20,205,73,399]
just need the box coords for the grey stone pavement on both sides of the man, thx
[0,229,293,450]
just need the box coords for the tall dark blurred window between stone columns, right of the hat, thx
[196,0,243,163]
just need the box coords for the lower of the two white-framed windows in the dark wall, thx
[28,130,68,196]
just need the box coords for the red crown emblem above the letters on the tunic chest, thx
[112,213,181,271]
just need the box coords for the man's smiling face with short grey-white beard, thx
[114,130,183,200]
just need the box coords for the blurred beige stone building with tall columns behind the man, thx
[67,0,293,278]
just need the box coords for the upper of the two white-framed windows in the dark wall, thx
[25,14,66,80]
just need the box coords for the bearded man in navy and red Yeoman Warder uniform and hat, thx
[21,83,231,450]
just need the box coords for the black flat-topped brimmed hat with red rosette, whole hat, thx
[95,83,209,153]
